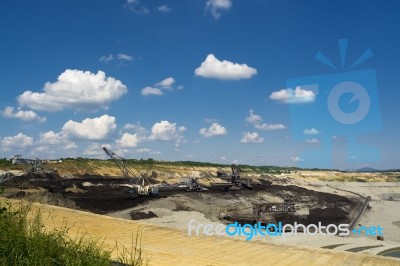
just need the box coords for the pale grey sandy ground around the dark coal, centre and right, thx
[108,180,400,254]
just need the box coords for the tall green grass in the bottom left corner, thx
[0,188,145,266]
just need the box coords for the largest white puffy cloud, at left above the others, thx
[18,69,128,112]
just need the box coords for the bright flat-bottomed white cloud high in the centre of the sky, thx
[194,54,257,80]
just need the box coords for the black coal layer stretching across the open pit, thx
[1,173,365,231]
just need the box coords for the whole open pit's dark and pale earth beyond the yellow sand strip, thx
[2,168,400,260]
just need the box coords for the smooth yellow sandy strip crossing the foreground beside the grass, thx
[3,200,400,265]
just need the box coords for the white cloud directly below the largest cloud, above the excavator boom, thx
[62,115,117,140]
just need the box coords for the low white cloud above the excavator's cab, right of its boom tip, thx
[148,120,186,147]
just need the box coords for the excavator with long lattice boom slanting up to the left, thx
[102,147,158,196]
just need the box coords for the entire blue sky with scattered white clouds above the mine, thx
[0,0,400,169]
